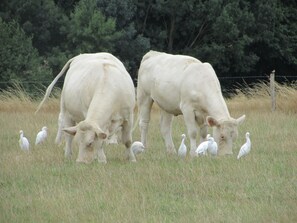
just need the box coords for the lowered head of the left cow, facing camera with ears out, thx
[63,121,107,163]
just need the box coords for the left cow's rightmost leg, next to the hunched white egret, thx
[122,118,136,162]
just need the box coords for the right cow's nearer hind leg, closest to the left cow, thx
[137,91,153,147]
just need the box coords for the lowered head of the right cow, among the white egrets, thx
[206,115,245,155]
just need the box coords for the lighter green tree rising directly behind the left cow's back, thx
[67,0,122,55]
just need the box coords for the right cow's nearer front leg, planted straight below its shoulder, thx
[182,107,197,157]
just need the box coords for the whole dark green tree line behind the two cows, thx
[0,0,297,94]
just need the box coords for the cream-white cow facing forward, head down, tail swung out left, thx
[37,53,136,163]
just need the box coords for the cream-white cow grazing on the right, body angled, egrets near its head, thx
[137,51,245,156]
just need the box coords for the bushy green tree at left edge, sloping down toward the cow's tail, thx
[0,18,51,93]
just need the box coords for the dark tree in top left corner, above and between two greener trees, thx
[1,0,68,56]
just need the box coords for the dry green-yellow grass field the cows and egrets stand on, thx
[0,83,297,222]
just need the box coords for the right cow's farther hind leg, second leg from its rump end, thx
[160,110,176,154]
